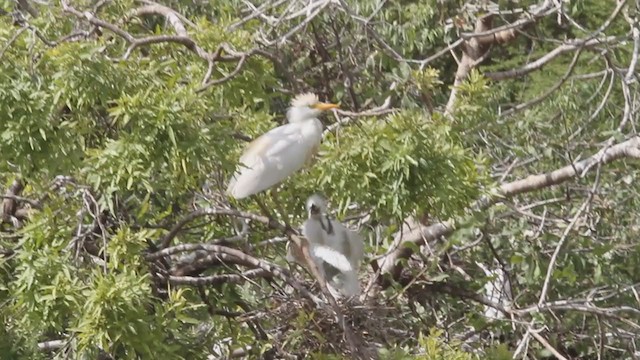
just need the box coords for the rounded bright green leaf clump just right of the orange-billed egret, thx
[311,111,479,220]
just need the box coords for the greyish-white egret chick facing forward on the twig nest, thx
[287,195,364,297]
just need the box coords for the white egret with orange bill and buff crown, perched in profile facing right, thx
[227,93,338,199]
